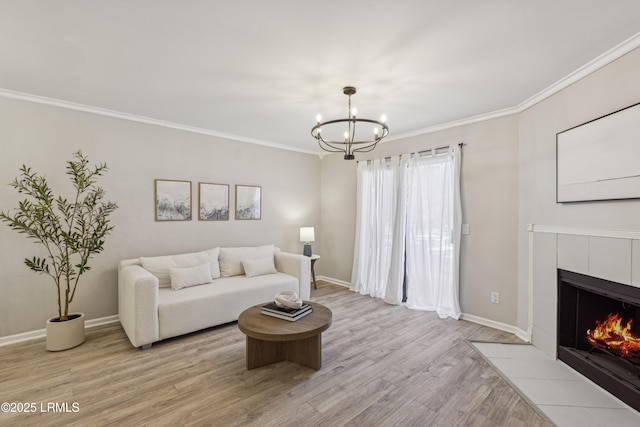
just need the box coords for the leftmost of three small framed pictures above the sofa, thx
[154,179,191,221]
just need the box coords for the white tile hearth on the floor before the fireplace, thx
[471,342,640,427]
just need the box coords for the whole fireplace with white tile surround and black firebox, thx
[529,225,640,411]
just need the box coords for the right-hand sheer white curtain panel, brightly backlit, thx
[406,146,462,319]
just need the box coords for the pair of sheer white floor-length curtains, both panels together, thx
[351,146,462,319]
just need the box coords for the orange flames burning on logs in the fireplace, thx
[586,313,640,364]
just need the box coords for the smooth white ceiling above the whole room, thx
[0,0,640,152]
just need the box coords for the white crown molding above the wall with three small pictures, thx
[0,89,318,156]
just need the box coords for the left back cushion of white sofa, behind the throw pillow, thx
[140,248,220,288]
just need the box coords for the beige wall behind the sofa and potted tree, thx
[0,98,320,336]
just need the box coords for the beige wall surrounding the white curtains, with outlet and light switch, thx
[321,115,518,325]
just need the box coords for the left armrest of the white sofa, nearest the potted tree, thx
[118,264,160,347]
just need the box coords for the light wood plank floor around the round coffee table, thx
[0,282,552,427]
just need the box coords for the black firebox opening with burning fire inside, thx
[558,270,640,411]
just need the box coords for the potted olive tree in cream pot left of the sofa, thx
[0,151,118,351]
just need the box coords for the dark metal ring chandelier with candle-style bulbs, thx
[311,86,389,160]
